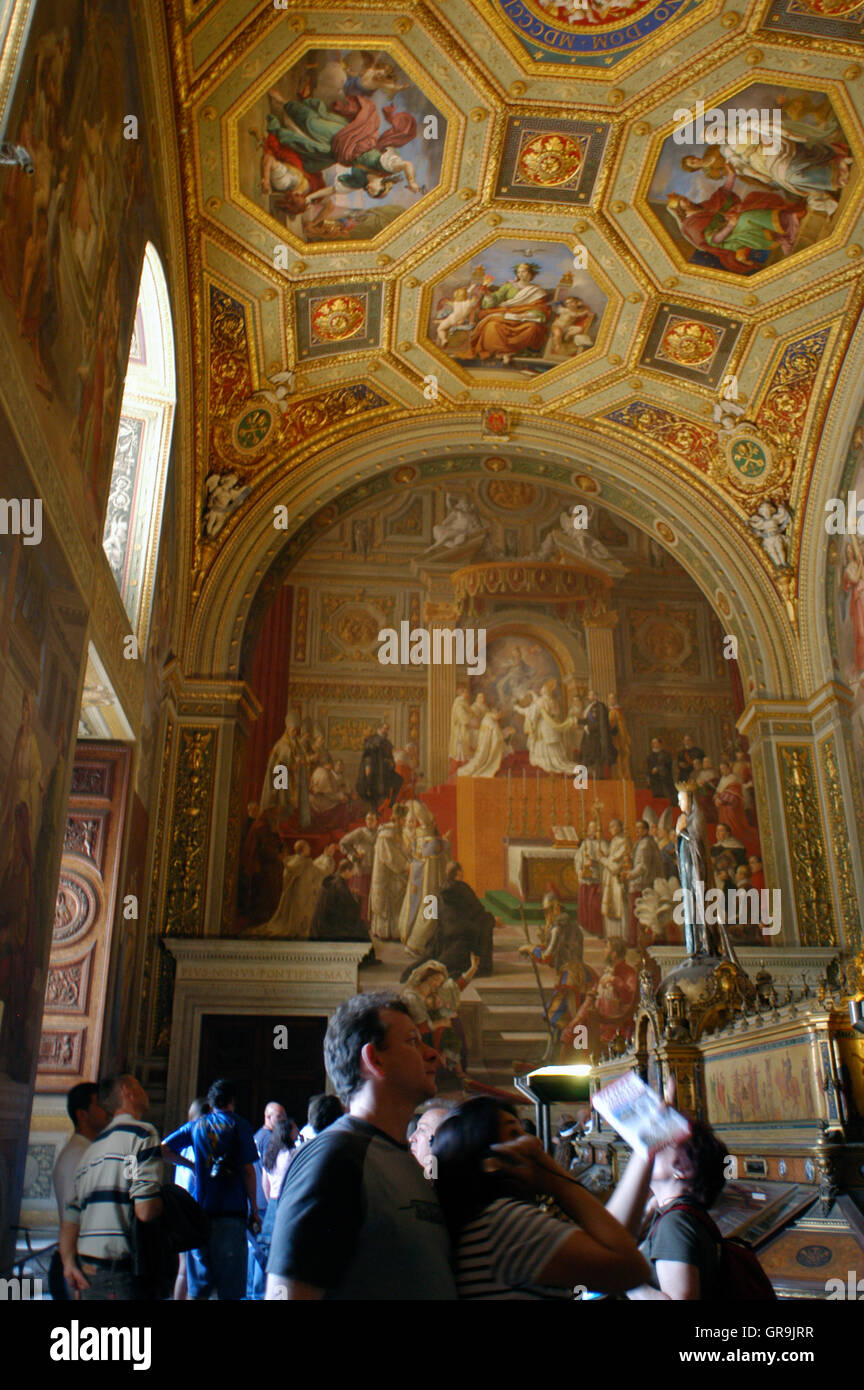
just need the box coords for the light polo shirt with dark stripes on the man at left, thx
[64,1115,163,1259]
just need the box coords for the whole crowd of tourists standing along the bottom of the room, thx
[51,991,772,1301]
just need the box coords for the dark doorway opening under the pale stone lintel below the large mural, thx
[197,1013,326,1129]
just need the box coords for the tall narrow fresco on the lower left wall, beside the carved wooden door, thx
[0,409,88,1225]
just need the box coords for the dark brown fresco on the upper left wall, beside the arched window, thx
[0,0,152,539]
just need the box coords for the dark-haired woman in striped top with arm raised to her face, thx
[432,1095,649,1300]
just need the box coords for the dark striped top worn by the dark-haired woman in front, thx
[456,1197,575,1300]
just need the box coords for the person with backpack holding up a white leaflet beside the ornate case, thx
[607,1083,775,1302]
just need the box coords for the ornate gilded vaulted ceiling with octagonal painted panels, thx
[161,0,864,672]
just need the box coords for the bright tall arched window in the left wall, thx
[101,245,176,652]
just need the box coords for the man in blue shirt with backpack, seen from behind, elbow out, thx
[163,1080,261,1300]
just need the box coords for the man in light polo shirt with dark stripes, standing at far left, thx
[60,1076,163,1300]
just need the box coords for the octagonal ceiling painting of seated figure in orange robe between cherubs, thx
[426,238,607,375]
